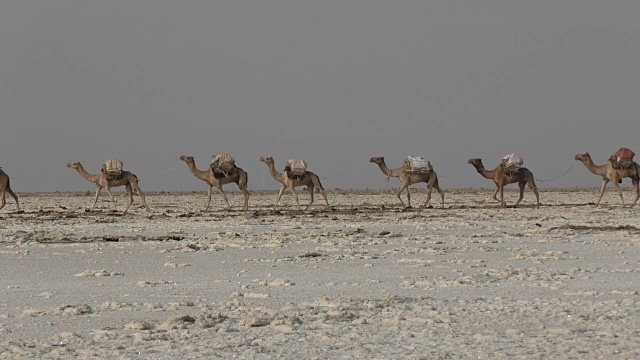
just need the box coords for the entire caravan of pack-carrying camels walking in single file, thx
[0,147,640,214]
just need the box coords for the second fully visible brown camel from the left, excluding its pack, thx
[180,155,250,211]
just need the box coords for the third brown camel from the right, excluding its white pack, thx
[369,156,444,209]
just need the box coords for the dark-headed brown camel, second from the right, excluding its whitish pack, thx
[469,158,540,208]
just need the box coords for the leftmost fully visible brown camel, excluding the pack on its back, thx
[67,161,149,215]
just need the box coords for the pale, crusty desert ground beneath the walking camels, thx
[0,188,640,359]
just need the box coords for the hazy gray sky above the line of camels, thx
[0,0,640,191]
